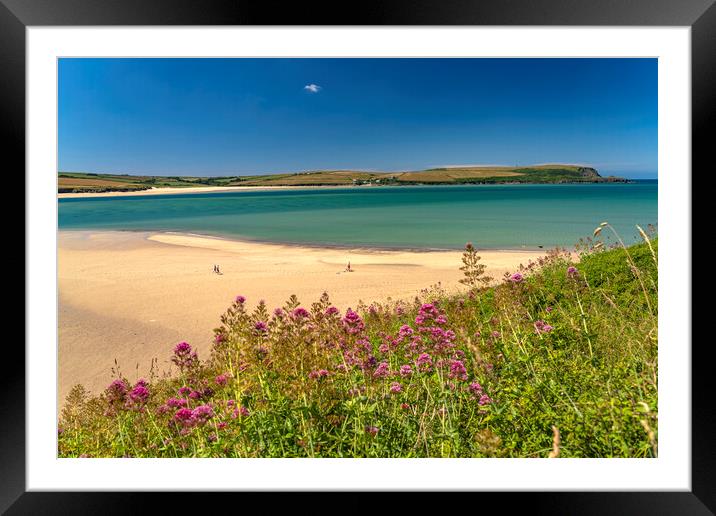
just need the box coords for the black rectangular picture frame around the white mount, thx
[0,0,716,514]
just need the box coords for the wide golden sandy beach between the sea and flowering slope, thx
[58,231,542,406]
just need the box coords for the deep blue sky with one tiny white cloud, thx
[58,58,657,178]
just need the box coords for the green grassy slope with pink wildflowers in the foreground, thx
[59,226,658,457]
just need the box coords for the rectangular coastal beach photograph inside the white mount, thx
[56,58,659,459]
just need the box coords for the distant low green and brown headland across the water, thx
[57,164,631,193]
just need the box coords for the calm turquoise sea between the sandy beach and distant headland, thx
[59,181,657,249]
